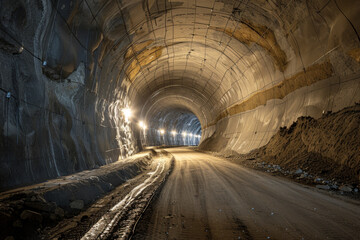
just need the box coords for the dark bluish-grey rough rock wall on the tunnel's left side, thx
[0,0,138,191]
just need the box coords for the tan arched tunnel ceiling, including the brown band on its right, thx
[83,0,359,132]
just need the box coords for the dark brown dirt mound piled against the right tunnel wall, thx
[247,104,360,185]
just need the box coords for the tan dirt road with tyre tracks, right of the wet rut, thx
[133,148,360,239]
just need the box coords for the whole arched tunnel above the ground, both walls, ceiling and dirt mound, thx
[0,0,360,239]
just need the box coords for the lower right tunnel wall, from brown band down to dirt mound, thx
[200,74,360,153]
